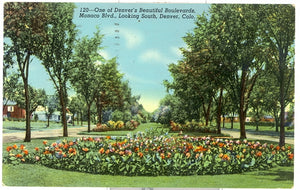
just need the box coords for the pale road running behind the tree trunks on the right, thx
[222,129,294,144]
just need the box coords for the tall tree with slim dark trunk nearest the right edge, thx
[260,4,295,146]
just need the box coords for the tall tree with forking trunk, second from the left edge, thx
[38,3,77,137]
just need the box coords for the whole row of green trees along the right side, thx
[162,4,295,145]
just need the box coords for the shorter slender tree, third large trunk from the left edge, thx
[71,29,103,132]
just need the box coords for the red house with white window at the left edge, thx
[3,100,26,119]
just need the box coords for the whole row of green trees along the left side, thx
[4,2,144,142]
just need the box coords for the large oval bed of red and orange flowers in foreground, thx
[3,133,294,176]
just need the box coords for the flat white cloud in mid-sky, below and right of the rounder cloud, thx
[139,49,174,65]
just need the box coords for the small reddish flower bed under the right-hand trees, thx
[170,121,217,133]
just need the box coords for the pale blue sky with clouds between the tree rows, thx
[29,3,209,112]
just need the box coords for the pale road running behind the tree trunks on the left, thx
[2,127,87,143]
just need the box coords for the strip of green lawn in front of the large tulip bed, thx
[2,164,294,188]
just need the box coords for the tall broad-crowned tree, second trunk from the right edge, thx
[210,4,265,138]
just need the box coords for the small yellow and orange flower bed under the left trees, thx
[92,120,140,132]
